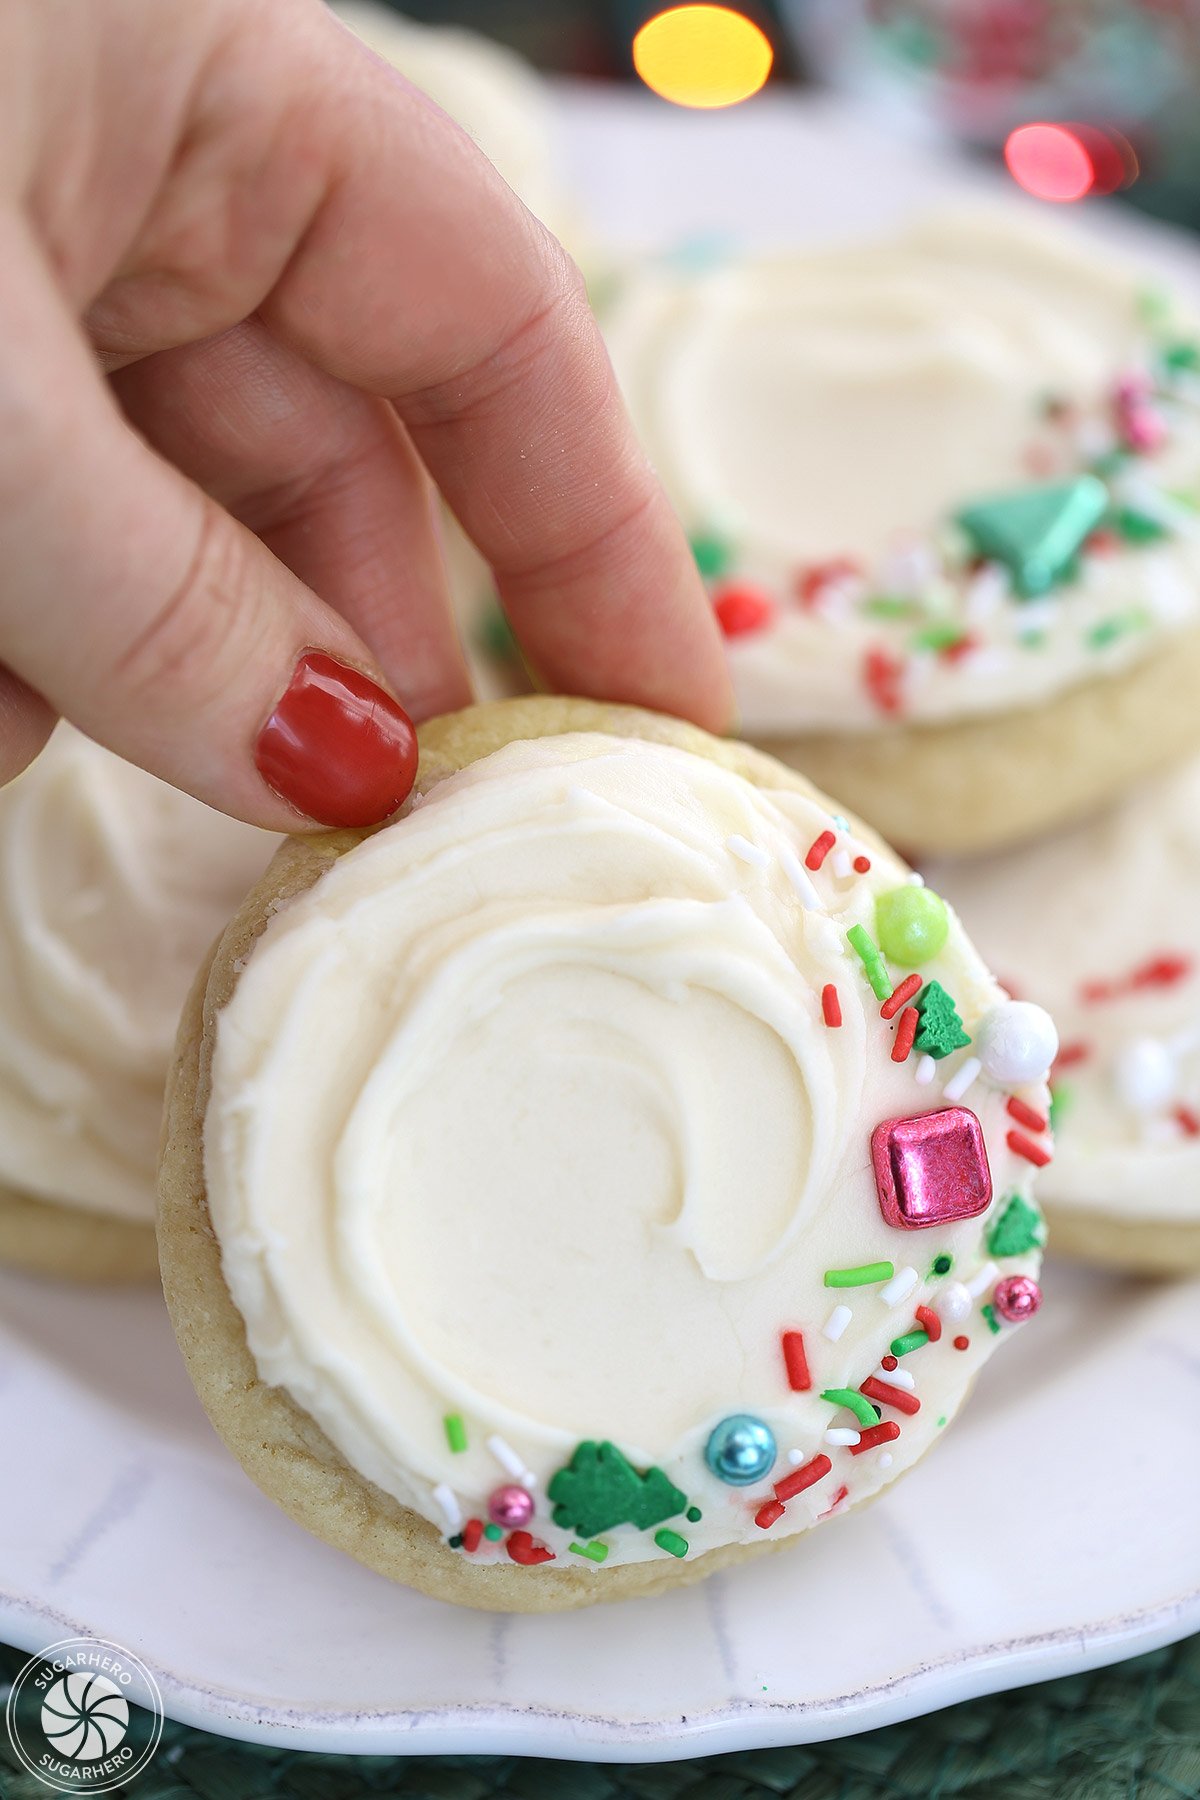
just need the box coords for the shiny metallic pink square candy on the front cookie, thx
[871,1107,991,1231]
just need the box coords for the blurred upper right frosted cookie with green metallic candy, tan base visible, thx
[604,211,1200,850]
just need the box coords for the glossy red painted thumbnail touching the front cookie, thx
[254,650,417,826]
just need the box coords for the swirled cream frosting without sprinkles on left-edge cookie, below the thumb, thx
[0,725,275,1222]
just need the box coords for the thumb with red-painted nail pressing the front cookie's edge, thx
[0,221,416,832]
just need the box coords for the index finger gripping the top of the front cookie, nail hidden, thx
[263,22,732,731]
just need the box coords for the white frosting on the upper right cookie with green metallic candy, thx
[604,209,1200,736]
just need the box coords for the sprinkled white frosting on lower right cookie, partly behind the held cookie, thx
[930,761,1200,1222]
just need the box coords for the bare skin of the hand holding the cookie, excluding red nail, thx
[0,0,732,830]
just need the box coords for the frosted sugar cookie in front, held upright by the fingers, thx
[158,698,1054,1611]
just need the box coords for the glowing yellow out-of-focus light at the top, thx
[633,5,775,106]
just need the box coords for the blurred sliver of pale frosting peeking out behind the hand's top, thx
[333,0,563,229]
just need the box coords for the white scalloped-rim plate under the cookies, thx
[0,90,1200,1760]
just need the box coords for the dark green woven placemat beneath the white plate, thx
[0,1638,1200,1800]
